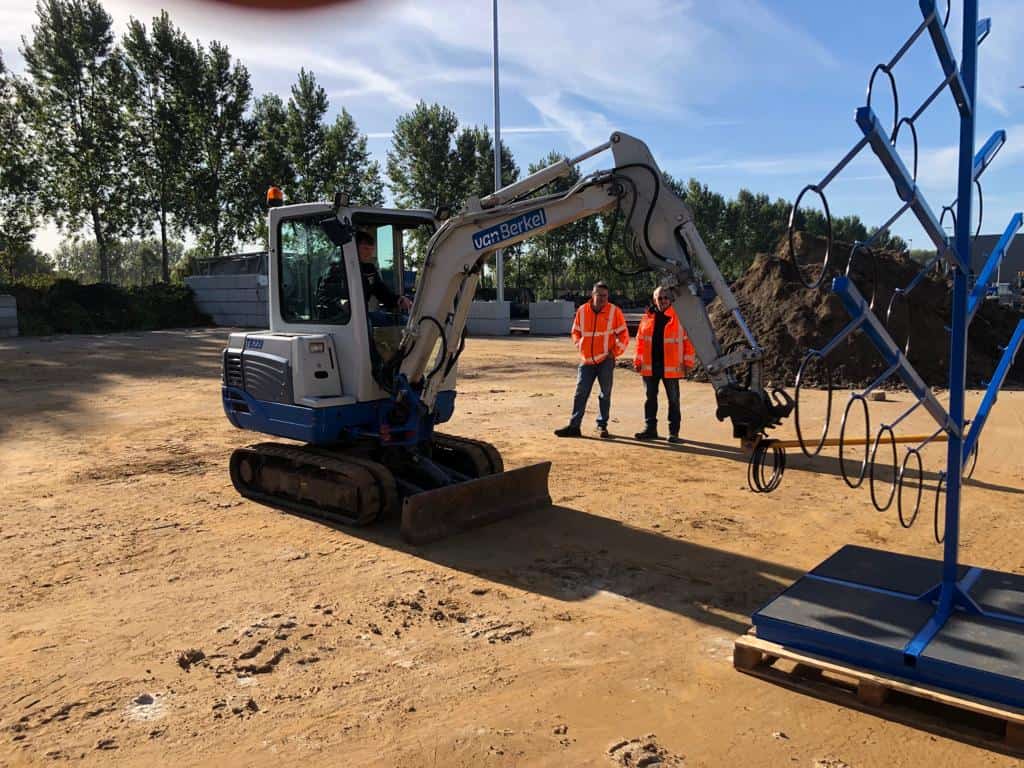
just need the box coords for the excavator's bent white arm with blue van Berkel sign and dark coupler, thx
[392,133,793,440]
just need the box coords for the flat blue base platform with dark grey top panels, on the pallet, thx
[753,546,1024,708]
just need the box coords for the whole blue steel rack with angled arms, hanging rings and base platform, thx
[753,0,1024,708]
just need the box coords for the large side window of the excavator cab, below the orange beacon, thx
[278,216,352,325]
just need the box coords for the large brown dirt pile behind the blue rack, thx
[711,237,1024,387]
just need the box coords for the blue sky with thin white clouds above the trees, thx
[0,0,1024,257]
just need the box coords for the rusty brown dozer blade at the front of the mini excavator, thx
[401,462,551,544]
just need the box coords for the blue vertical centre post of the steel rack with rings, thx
[936,0,978,622]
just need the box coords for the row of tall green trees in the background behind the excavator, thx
[0,0,913,298]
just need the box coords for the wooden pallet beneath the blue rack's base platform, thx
[732,630,1024,755]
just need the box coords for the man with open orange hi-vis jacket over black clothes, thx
[633,288,696,442]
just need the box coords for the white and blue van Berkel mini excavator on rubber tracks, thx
[221,133,793,544]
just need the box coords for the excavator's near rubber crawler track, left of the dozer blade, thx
[231,442,387,525]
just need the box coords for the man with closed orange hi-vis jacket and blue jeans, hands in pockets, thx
[555,283,630,437]
